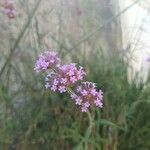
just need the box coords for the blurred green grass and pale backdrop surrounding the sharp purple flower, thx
[0,0,150,150]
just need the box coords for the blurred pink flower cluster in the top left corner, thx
[4,0,16,19]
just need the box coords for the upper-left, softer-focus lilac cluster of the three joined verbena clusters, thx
[34,51,60,72]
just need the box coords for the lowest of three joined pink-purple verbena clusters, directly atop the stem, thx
[71,82,103,112]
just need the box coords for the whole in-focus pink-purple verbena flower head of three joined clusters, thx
[34,51,103,112]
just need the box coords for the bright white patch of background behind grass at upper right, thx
[120,0,150,81]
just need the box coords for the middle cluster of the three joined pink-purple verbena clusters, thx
[46,64,86,93]
